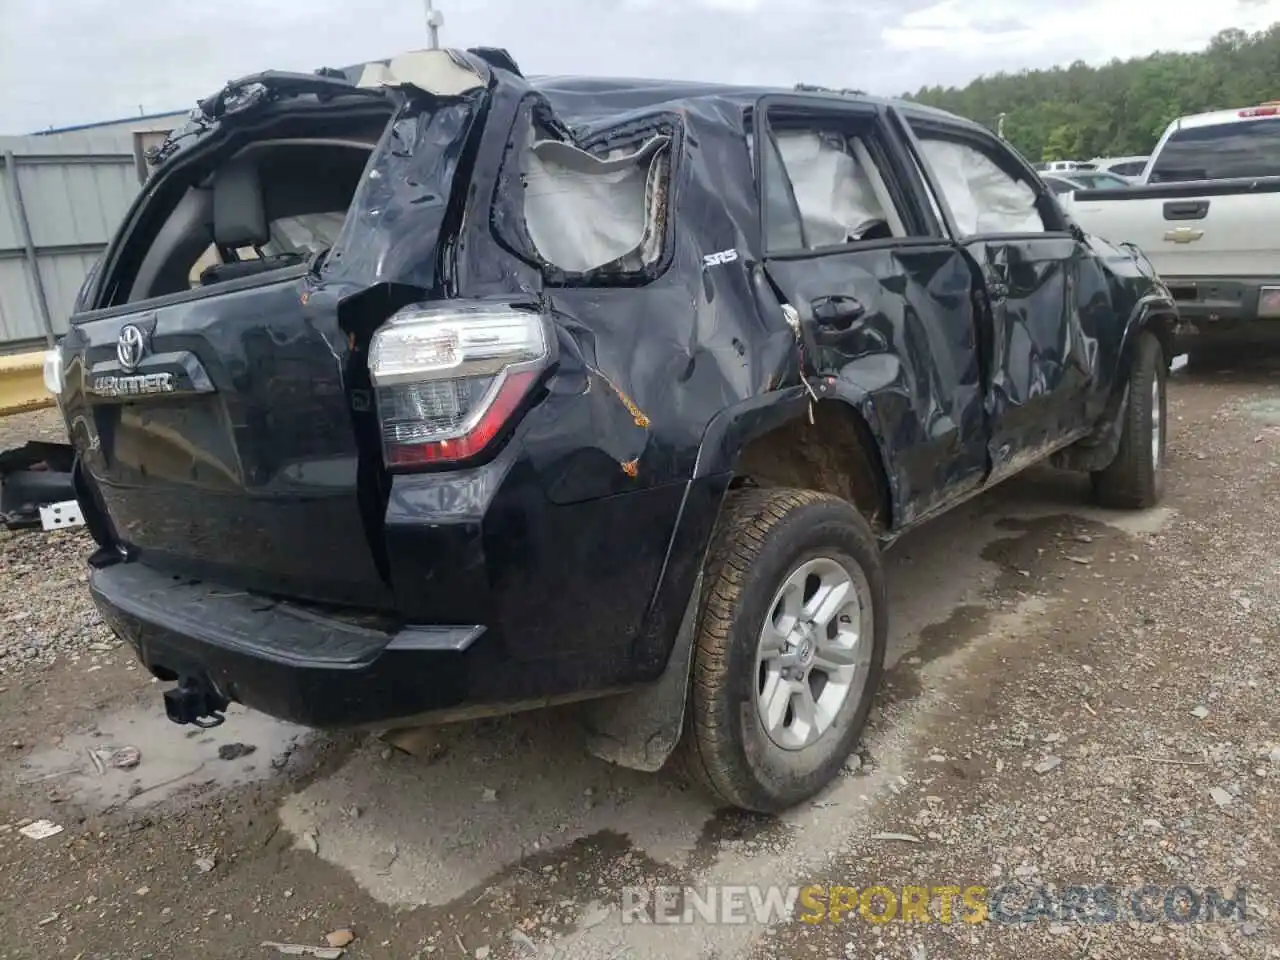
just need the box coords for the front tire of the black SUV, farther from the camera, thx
[1091,333,1169,509]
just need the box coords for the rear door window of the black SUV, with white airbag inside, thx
[760,115,909,256]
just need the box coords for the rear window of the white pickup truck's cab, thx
[1147,116,1280,183]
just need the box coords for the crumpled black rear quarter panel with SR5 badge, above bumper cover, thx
[458,85,794,503]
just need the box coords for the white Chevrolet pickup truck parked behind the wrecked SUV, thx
[1064,102,1280,353]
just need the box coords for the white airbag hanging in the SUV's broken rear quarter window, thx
[525,136,671,273]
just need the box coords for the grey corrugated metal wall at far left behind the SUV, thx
[0,114,183,352]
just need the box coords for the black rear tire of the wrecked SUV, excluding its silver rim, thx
[682,489,888,813]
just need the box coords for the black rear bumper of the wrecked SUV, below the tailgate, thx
[90,563,485,728]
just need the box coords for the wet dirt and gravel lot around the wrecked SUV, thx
[0,365,1280,960]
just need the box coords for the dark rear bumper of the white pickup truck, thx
[1162,275,1280,348]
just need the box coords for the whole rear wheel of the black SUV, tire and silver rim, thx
[684,489,888,813]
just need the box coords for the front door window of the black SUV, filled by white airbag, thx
[916,133,1048,237]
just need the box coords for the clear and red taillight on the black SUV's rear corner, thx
[369,303,548,468]
